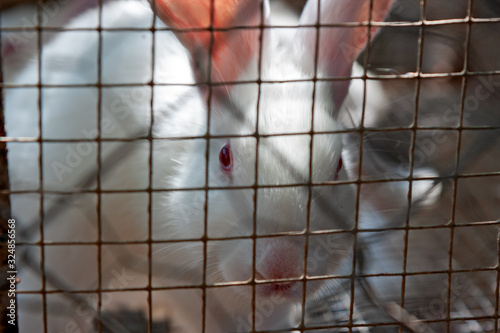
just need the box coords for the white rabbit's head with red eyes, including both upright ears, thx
[153,0,392,300]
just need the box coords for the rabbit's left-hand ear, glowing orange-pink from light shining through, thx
[149,0,267,82]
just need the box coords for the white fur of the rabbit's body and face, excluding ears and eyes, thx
[6,2,394,333]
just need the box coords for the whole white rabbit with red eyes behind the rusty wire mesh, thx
[6,0,392,332]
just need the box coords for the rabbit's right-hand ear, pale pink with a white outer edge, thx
[297,0,393,111]
